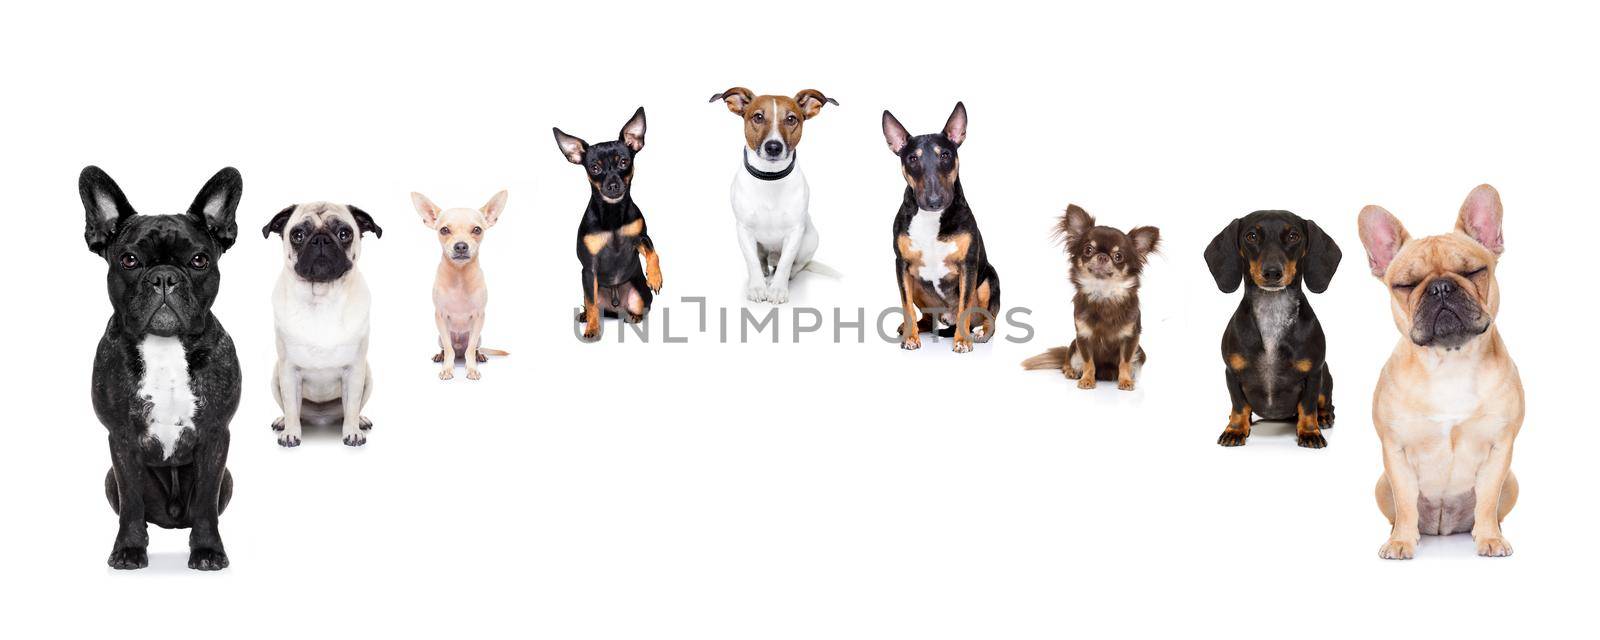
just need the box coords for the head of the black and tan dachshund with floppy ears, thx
[1205,211,1344,293]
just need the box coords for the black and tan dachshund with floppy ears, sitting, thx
[1205,211,1341,450]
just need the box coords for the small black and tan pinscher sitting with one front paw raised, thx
[554,107,661,341]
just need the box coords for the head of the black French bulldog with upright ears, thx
[78,166,243,338]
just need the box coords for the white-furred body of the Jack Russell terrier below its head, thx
[731,147,818,304]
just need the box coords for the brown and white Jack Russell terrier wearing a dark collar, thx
[710,86,838,304]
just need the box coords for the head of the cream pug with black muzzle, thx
[261,202,384,283]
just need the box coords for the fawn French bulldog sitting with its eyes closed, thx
[1358,184,1523,560]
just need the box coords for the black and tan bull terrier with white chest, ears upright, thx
[883,102,1000,354]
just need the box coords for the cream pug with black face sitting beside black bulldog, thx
[261,202,384,446]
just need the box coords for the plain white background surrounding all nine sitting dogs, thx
[0,2,1600,638]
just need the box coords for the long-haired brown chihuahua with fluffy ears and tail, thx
[1022,205,1162,390]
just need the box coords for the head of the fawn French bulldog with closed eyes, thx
[1358,184,1506,349]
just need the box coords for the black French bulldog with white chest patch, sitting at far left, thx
[78,166,243,571]
